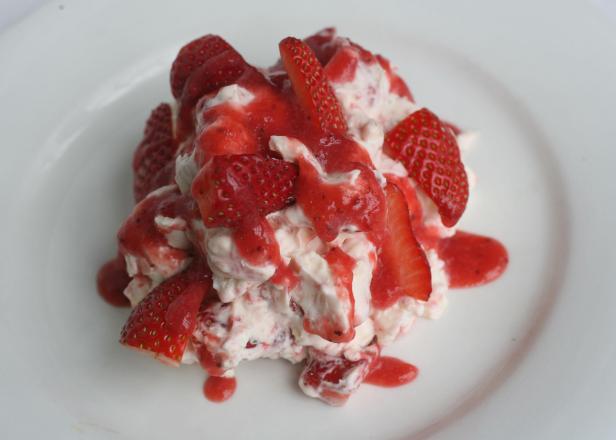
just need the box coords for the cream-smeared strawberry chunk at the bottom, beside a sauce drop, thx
[299,344,379,406]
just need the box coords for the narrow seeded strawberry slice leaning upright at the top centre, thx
[279,37,347,135]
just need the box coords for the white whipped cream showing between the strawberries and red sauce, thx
[120,43,474,384]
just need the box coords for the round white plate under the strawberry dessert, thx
[0,0,616,439]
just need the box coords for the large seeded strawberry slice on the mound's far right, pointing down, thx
[383,108,468,226]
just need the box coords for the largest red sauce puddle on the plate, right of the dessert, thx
[438,231,509,288]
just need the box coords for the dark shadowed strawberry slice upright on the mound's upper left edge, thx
[133,104,177,202]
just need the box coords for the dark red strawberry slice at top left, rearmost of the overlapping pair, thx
[170,35,233,99]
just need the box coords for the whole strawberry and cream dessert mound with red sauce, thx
[98,28,508,405]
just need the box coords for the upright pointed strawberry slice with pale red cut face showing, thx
[370,183,432,309]
